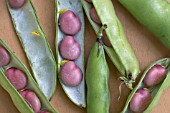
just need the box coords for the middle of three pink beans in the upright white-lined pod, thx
[59,36,81,60]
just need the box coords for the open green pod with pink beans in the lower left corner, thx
[0,39,57,113]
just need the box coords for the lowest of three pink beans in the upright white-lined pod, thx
[60,61,82,86]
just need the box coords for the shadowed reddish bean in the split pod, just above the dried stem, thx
[90,7,101,24]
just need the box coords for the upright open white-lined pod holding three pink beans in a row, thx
[56,0,86,107]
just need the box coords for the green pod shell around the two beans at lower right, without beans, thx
[122,58,170,113]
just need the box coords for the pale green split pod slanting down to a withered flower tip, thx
[81,0,140,89]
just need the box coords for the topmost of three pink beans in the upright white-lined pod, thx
[59,10,81,35]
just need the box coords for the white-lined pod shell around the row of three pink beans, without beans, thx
[55,0,86,107]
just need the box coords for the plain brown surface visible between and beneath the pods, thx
[0,0,170,113]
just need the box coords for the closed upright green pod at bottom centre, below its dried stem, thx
[86,42,110,113]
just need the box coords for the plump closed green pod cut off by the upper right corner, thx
[119,0,170,49]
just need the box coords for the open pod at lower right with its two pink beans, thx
[122,58,170,113]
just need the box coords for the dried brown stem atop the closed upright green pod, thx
[97,24,107,56]
